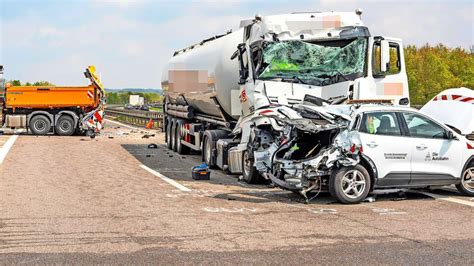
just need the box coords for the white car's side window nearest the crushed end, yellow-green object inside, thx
[359,112,402,136]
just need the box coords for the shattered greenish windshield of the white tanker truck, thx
[258,38,367,86]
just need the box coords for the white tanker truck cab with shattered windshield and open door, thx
[234,10,409,115]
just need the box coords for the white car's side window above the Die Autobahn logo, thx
[403,113,446,139]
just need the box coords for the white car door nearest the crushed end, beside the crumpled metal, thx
[359,111,411,187]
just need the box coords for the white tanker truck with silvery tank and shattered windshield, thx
[162,9,409,183]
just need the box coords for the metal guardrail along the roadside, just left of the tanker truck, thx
[105,107,163,131]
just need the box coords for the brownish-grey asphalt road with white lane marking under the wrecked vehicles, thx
[0,123,474,264]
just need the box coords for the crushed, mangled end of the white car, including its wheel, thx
[243,101,370,203]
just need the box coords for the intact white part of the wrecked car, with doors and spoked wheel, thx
[340,106,474,203]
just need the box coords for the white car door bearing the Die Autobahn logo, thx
[402,112,466,185]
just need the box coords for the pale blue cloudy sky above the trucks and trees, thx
[0,0,474,88]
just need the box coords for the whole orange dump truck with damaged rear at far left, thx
[2,66,105,136]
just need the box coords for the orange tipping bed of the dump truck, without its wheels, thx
[5,85,100,109]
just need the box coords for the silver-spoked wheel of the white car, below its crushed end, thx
[329,165,370,204]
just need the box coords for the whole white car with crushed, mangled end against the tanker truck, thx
[243,101,474,203]
